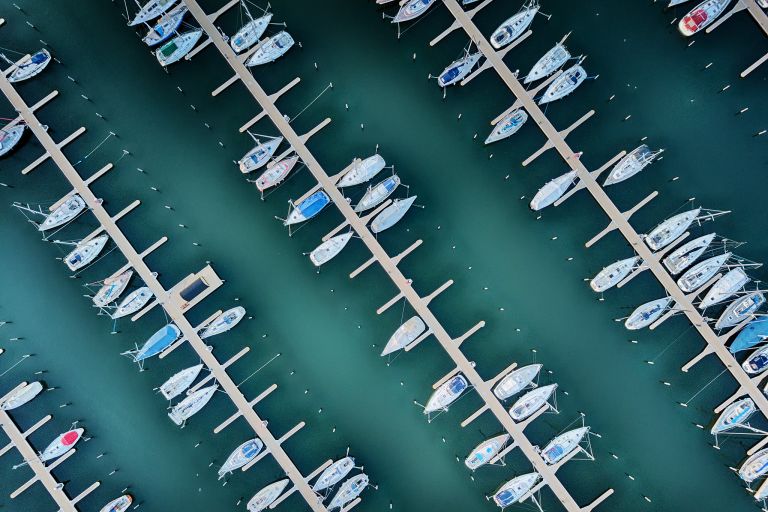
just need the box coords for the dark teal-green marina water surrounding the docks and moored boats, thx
[0,0,768,512]
